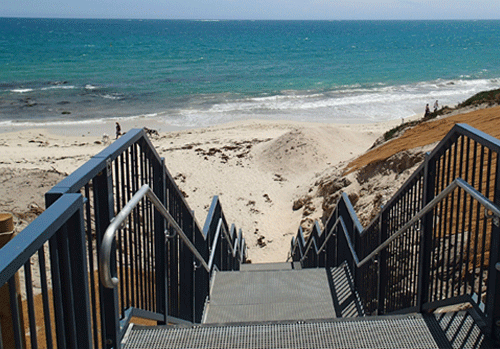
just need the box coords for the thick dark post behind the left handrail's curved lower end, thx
[93,160,120,349]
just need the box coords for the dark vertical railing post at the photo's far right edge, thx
[486,154,500,343]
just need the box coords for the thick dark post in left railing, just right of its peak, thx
[153,158,168,325]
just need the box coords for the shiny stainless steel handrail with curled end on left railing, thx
[99,184,213,288]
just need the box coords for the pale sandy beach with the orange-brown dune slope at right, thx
[0,107,500,263]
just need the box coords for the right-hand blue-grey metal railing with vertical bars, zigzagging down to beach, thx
[291,124,500,338]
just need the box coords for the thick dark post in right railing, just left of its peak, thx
[417,153,436,312]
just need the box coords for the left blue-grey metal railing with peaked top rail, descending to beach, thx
[0,130,245,348]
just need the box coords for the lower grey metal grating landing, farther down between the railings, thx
[203,269,336,324]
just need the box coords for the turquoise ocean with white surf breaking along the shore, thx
[0,18,500,127]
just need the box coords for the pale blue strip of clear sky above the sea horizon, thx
[0,0,500,20]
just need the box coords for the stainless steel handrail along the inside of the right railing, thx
[352,178,500,268]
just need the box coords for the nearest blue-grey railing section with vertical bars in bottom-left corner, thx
[0,194,92,348]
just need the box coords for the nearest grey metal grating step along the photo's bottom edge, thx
[122,312,493,349]
